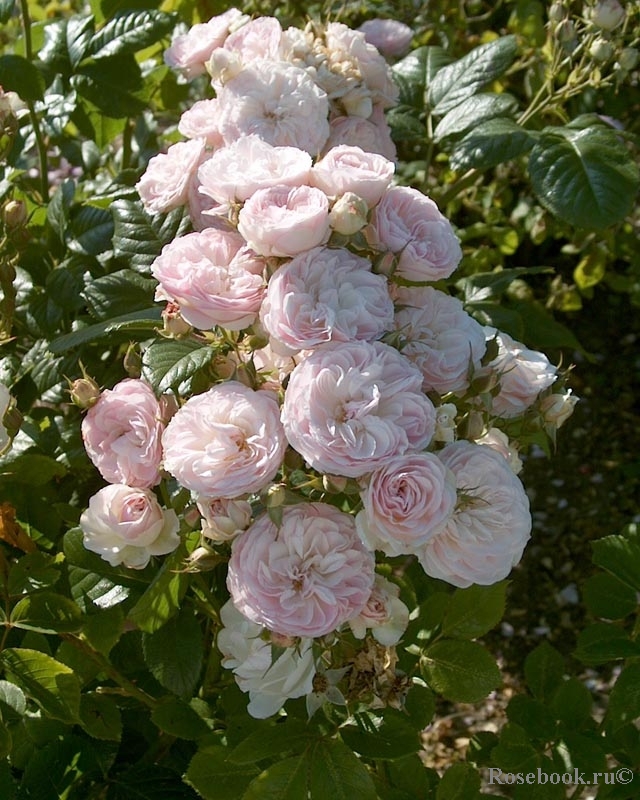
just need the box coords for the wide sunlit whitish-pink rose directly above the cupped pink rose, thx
[198,134,311,203]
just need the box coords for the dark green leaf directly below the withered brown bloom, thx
[340,714,421,759]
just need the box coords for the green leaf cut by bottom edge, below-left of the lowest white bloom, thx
[185,745,260,800]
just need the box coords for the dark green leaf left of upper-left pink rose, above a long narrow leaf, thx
[82,269,158,319]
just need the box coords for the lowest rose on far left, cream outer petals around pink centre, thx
[80,484,180,569]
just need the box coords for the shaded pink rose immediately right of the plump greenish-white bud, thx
[365,186,462,282]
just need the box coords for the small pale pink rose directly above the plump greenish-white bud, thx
[311,144,395,207]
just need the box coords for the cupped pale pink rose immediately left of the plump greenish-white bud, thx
[238,186,330,256]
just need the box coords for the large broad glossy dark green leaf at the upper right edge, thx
[529,125,640,230]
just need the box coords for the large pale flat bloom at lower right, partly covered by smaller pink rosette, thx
[419,441,531,587]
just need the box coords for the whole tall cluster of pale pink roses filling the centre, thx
[81,9,573,717]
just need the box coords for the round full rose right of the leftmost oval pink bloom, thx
[162,381,286,498]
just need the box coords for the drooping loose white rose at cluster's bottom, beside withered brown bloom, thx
[217,600,316,719]
